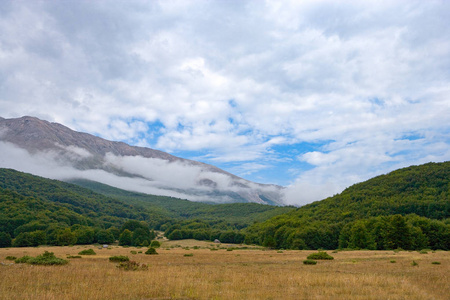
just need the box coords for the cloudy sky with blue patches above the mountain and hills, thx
[0,0,450,204]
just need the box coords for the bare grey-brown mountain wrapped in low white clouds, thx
[0,117,283,205]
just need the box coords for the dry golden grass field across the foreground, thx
[0,241,450,299]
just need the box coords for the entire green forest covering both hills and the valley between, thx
[0,162,450,250]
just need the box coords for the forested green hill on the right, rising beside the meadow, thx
[246,162,450,249]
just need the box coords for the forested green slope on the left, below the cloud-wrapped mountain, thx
[0,169,293,247]
